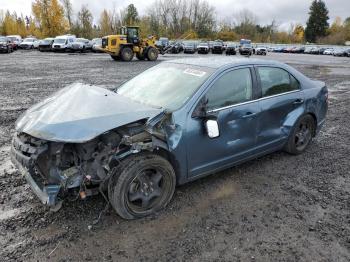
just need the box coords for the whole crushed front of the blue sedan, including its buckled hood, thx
[11,84,176,209]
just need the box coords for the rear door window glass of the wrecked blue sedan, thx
[258,67,299,97]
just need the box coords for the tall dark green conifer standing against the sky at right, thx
[305,0,329,43]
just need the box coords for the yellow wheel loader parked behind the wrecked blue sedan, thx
[101,26,159,61]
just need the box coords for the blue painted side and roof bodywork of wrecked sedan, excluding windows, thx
[161,58,328,184]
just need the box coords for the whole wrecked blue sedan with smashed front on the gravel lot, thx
[11,58,328,219]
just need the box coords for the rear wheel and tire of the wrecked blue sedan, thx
[284,114,316,155]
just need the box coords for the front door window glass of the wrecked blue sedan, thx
[206,68,253,110]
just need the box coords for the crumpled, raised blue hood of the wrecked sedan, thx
[16,83,163,143]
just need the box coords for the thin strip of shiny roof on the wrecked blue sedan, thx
[167,57,283,69]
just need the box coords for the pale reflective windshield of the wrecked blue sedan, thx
[117,63,213,111]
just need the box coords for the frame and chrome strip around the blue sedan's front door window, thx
[205,65,254,113]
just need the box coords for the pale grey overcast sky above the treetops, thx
[0,0,350,29]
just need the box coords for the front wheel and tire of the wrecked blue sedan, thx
[108,153,176,219]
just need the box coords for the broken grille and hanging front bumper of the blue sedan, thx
[11,136,61,206]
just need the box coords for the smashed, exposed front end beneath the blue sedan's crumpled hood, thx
[11,120,166,207]
